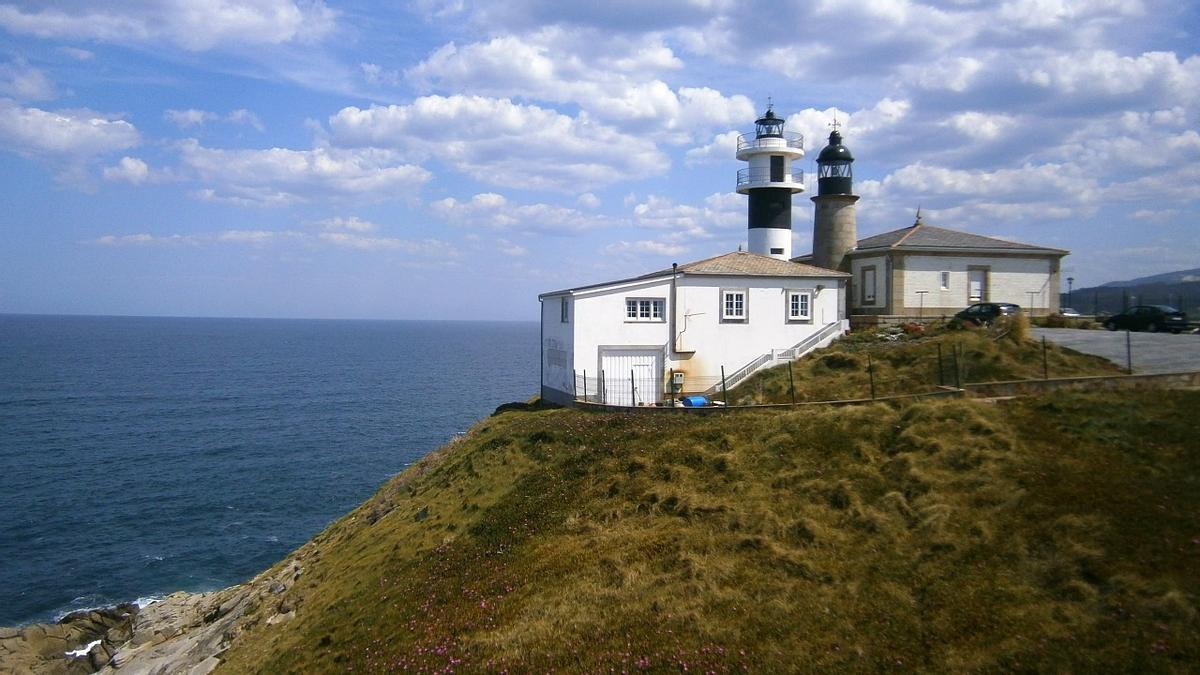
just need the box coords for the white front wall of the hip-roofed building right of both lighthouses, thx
[904,255,1058,311]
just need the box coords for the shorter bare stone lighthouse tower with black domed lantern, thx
[812,120,858,271]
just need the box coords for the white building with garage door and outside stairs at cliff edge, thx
[538,251,848,406]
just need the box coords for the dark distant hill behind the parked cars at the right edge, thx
[1061,268,1200,316]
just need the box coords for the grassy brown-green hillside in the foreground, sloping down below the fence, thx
[221,384,1200,673]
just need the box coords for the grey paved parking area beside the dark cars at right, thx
[1031,328,1200,372]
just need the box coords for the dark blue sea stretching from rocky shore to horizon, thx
[0,315,538,626]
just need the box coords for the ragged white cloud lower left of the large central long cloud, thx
[180,139,430,204]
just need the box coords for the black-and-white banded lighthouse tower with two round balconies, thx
[737,106,804,261]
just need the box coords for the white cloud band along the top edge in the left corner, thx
[0,0,336,52]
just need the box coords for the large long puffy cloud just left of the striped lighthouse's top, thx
[329,96,670,192]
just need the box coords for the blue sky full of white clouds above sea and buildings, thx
[0,0,1200,321]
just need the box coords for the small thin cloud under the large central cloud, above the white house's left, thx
[430,192,611,233]
